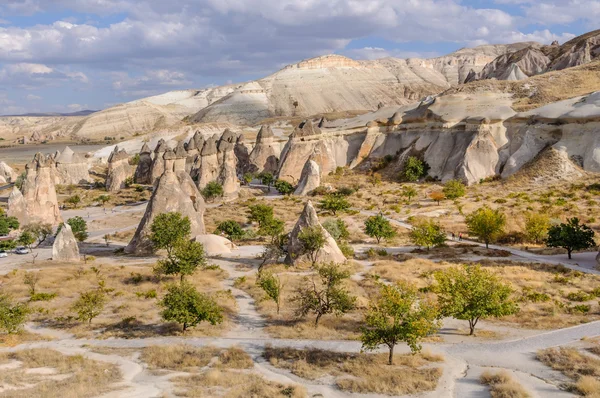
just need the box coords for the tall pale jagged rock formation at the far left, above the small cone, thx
[8,153,62,226]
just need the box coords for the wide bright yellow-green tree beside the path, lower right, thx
[434,265,519,335]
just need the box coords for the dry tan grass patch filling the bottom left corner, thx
[0,349,121,398]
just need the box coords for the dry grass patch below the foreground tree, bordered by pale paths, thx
[264,346,443,395]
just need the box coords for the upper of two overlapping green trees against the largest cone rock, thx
[150,212,192,258]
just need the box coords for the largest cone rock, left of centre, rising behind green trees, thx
[125,170,205,255]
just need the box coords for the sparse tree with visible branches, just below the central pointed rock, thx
[292,263,356,327]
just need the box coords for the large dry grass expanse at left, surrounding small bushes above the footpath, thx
[0,260,237,338]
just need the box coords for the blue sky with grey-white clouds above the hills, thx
[0,0,600,114]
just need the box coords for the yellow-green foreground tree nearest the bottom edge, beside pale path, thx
[361,282,440,365]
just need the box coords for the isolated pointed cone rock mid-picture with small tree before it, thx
[286,201,346,264]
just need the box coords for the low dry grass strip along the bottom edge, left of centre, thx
[172,369,307,398]
